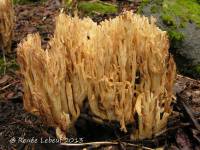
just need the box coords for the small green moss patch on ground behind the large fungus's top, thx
[78,1,117,14]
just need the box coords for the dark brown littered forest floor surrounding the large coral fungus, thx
[0,1,200,150]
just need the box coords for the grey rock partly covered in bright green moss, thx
[138,0,200,79]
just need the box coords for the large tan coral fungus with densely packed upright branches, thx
[17,12,176,139]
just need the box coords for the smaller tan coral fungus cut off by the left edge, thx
[0,0,14,53]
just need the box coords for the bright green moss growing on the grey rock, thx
[160,0,200,48]
